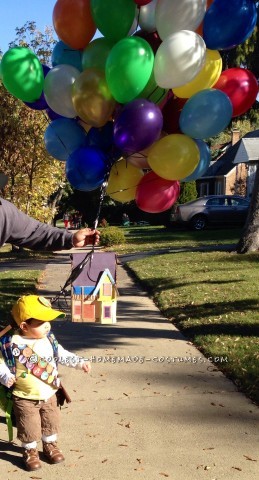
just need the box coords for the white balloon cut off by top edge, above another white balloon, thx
[155,0,207,40]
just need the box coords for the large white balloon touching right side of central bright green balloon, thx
[154,30,206,88]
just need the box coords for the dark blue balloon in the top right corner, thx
[203,0,257,50]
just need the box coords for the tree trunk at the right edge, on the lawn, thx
[237,163,259,253]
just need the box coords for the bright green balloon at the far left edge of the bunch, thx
[1,47,44,102]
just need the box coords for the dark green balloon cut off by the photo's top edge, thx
[91,0,136,42]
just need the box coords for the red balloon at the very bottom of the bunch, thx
[136,172,180,213]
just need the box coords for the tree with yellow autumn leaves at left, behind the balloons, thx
[0,22,64,222]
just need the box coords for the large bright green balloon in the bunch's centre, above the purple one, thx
[105,37,154,103]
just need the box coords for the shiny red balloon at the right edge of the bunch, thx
[213,67,258,117]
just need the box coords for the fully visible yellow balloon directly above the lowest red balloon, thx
[148,133,200,180]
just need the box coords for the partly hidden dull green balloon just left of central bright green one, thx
[82,37,114,71]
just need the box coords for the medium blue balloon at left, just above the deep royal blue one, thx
[44,117,87,161]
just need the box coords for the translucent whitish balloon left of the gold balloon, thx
[43,64,81,118]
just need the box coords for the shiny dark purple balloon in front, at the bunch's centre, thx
[114,98,163,154]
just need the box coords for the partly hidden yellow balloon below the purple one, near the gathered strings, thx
[106,158,143,203]
